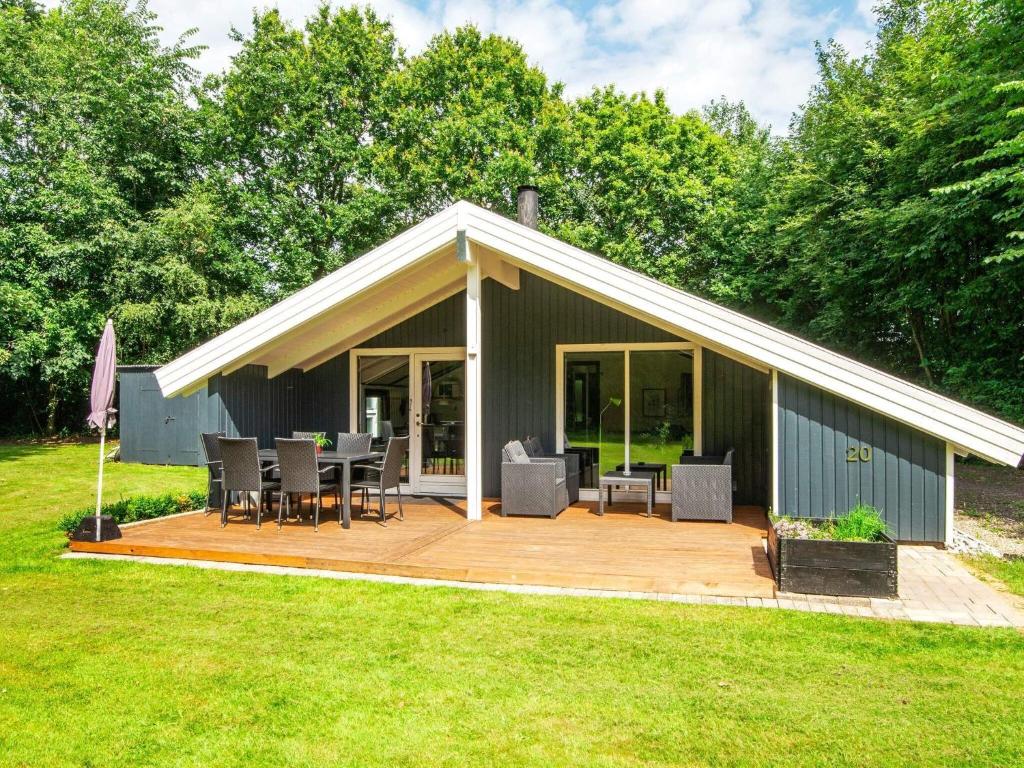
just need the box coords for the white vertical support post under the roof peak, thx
[466,242,483,520]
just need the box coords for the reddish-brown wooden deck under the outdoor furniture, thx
[72,500,774,597]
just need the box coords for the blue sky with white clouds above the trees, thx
[64,0,874,133]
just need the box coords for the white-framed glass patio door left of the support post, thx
[410,351,466,496]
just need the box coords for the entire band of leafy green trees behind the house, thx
[0,0,1024,432]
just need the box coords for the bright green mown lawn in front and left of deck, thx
[0,445,1024,766]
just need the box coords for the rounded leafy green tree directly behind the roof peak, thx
[378,27,565,223]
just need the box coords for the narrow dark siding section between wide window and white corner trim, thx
[700,349,771,506]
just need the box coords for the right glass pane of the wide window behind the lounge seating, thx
[630,350,693,489]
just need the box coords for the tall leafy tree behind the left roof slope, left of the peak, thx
[200,4,400,295]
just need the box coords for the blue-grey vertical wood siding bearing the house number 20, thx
[778,374,946,542]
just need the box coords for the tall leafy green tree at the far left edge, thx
[0,0,195,432]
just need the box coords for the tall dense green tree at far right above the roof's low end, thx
[773,0,1024,419]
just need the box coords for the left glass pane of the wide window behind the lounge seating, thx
[564,352,626,488]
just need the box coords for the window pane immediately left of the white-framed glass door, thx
[357,354,409,482]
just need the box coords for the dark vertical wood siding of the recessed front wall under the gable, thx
[125,271,768,514]
